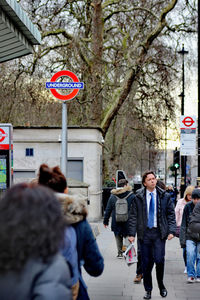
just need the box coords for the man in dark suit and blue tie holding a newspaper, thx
[128,170,176,299]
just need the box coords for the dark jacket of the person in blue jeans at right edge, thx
[179,201,200,248]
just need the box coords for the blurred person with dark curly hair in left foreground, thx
[0,183,72,300]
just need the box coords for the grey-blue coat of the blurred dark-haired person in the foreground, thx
[0,254,72,300]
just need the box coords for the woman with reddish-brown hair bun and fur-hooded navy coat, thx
[38,164,104,300]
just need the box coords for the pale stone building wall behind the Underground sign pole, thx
[13,127,103,221]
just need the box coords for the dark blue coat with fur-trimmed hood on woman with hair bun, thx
[57,193,104,300]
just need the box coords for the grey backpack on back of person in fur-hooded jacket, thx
[115,192,133,222]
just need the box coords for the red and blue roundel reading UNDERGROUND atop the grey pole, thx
[46,70,84,101]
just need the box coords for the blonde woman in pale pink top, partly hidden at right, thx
[175,185,194,274]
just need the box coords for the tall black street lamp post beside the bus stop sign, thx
[178,44,188,197]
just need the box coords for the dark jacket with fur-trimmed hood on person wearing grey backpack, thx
[103,186,135,237]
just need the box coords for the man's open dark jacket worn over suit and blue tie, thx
[128,187,176,240]
